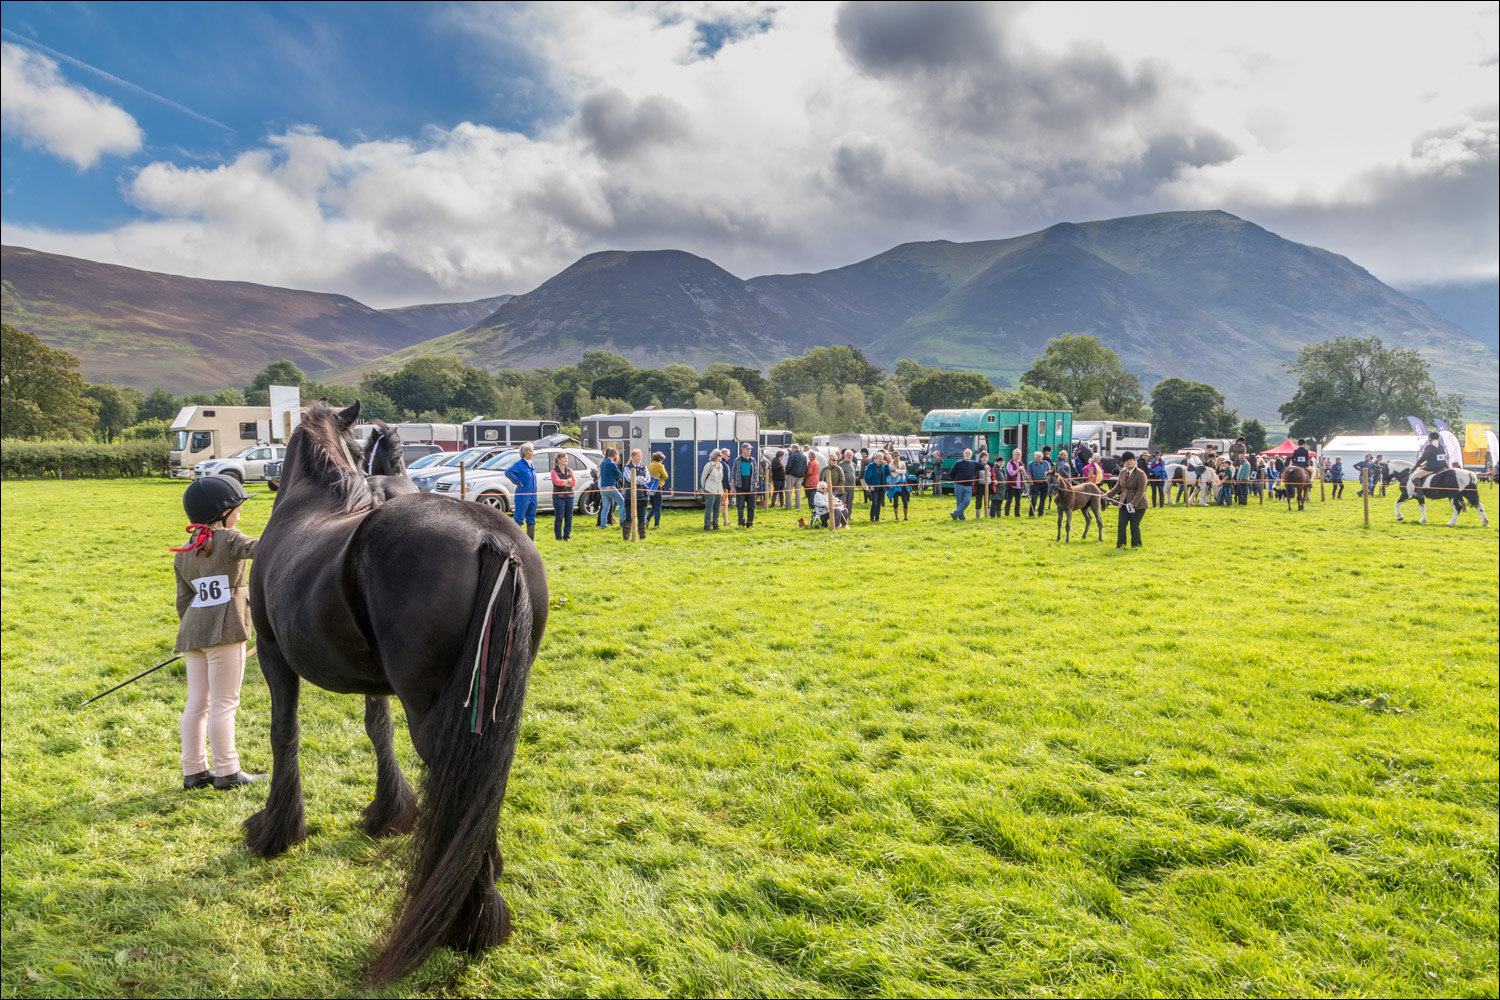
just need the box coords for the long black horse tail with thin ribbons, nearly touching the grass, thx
[369,535,533,985]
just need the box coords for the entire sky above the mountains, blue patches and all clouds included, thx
[0,0,1500,306]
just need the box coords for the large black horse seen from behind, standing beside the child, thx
[245,402,548,984]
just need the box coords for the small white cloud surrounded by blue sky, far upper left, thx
[0,42,143,169]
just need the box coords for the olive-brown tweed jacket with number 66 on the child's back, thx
[173,528,258,652]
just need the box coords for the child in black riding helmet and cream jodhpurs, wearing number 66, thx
[173,475,266,792]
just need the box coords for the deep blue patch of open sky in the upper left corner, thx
[0,1,558,229]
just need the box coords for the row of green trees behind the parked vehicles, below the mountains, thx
[0,324,1464,450]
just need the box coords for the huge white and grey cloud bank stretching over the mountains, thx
[5,3,1497,304]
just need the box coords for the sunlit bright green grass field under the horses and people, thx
[0,481,1500,997]
